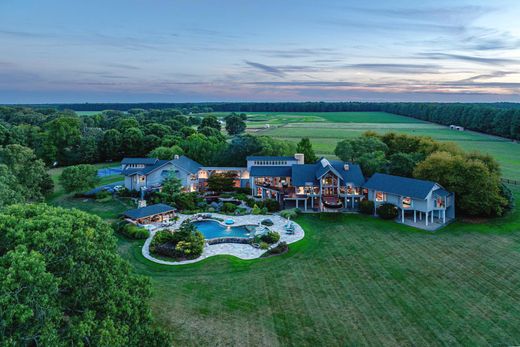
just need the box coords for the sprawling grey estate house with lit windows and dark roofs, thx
[121,154,455,226]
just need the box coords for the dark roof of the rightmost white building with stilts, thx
[363,173,437,199]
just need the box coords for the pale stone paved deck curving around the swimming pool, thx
[142,213,305,265]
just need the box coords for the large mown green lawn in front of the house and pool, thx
[120,188,520,346]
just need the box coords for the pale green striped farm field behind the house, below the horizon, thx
[247,112,520,180]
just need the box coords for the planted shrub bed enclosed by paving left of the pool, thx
[150,221,204,260]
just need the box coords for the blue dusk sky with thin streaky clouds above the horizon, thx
[0,0,520,103]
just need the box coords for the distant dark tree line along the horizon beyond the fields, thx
[28,102,520,140]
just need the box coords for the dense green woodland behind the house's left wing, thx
[0,107,296,166]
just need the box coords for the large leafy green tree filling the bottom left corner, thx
[0,204,170,346]
